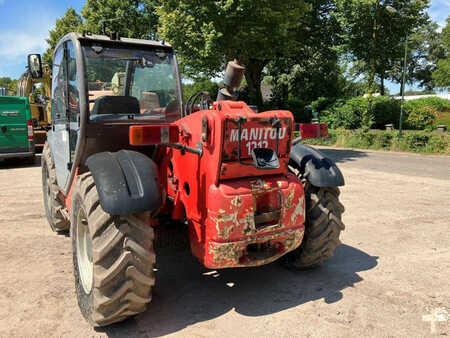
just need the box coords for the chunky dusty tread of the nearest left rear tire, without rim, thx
[74,173,155,326]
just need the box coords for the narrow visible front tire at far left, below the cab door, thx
[41,142,70,232]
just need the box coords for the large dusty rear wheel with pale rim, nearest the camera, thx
[70,173,155,326]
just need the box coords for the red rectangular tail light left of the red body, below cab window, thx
[130,125,178,146]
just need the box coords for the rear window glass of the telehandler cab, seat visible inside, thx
[83,45,181,122]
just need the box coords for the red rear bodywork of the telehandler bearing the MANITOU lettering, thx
[159,101,305,268]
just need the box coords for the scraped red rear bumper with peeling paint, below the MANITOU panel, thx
[190,174,305,269]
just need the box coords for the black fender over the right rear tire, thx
[289,143,345,187]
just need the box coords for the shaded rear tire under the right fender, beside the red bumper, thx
[282,177,345,270]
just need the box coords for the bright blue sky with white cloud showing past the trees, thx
[0,0,450,94]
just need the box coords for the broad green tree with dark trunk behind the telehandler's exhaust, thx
[157,0,308,106]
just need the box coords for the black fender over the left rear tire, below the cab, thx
[86,150,162,216]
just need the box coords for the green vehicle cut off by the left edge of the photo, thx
[0,96,34,159]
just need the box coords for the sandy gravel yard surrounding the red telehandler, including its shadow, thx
[0,148,450,337]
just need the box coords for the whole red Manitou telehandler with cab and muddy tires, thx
[39,33,344,326]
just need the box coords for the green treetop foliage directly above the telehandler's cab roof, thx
[81,0,161,39]
